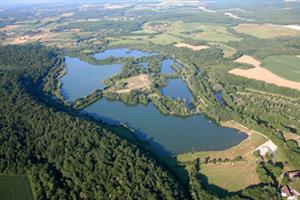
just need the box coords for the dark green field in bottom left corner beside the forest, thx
[0,175,34,200]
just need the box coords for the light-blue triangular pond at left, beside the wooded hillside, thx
[61,57,122,101]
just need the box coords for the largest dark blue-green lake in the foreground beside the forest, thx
[84,99,247,154]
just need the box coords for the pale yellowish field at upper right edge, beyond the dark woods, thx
[234,24,300,39]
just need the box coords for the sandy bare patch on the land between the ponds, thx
[115,74,151,93]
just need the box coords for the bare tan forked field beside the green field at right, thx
[229,55,300,90]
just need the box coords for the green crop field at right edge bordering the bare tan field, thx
[262,55,300,82]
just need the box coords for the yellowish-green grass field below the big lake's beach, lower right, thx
[200,156,259,192]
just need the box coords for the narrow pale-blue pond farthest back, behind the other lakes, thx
[94,48,157,60]
